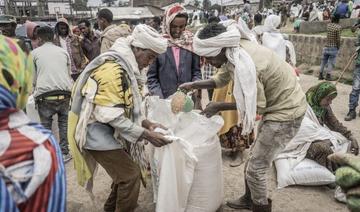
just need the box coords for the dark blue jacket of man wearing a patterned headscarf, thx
[147,47,201,98]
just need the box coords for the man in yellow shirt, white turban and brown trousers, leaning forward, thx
[68,25,173,212]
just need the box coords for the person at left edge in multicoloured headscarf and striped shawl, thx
[0,35,66,212]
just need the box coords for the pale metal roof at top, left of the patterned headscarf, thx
[102,7,154,20]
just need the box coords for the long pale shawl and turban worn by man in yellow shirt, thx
[69,25,167,191]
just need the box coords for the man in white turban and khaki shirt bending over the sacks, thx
[180,22,307,212]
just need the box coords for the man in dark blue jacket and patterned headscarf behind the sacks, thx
[147,5,201,98]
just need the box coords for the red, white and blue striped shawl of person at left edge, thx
[0,111,66,212]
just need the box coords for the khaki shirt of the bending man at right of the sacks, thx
[213,40,307,121]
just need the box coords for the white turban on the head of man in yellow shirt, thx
[130,24,168,54]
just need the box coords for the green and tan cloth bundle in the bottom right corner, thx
[329,153,360,211]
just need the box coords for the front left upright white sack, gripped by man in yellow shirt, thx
[151,131,197,212]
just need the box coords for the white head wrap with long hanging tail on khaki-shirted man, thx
[193,20,257,135]
